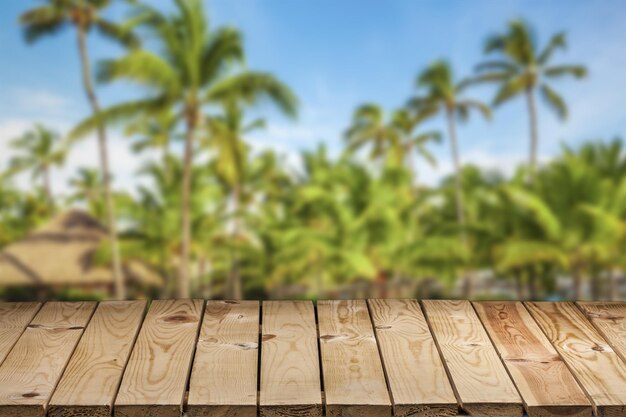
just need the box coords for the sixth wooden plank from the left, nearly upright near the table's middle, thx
[259,301,322,417]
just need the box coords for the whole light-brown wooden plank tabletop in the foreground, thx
[0,300,626,417]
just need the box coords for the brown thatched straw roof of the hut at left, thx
[0,210,163,287]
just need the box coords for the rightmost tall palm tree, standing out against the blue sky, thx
[476,20,587,183]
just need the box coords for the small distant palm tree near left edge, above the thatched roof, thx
[9,124,67,208]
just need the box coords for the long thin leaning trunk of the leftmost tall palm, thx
[78,26,126,300]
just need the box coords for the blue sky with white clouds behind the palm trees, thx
[0,0,626,191]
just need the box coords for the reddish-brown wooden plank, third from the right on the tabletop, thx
[473,301,592,417]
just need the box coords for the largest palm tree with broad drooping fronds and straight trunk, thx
[72,0,297,297]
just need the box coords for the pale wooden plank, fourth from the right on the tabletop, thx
[423,301,524,417]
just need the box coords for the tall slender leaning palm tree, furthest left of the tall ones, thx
[20,0,137,299]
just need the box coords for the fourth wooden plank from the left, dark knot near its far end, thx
[115,300,204,417]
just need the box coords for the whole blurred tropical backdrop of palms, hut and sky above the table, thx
[0,0,626,300]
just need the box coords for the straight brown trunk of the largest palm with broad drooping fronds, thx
[178,112,196,298]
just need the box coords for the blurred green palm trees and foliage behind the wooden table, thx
[0,4,626,299]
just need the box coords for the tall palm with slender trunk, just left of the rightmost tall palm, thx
[409,60,491,229]
